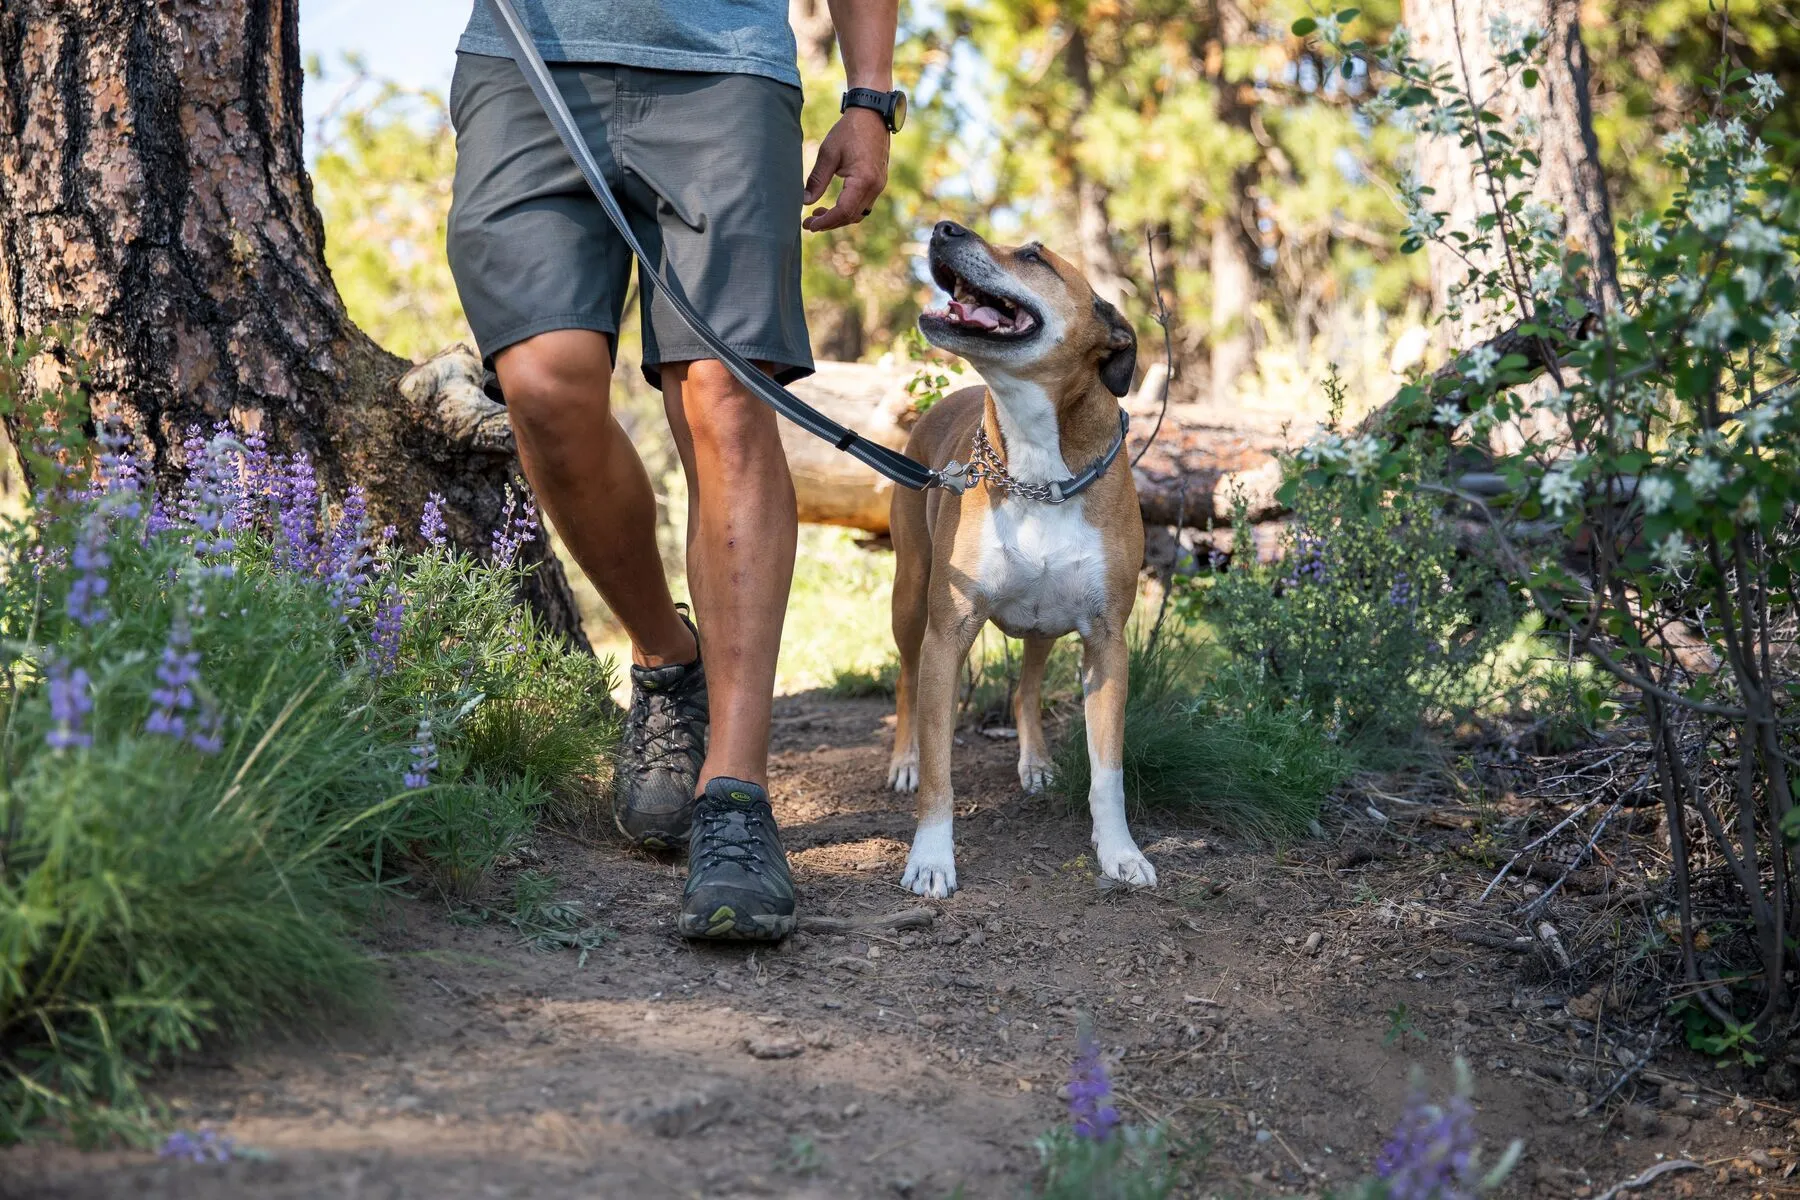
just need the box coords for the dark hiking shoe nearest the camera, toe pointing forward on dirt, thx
[675,777,794,941]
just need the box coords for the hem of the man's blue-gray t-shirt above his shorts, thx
[457,0,799,88]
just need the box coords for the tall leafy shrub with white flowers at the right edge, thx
[1296,16,1800,1038]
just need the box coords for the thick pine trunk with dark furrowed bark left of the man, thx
[0,0,585,646]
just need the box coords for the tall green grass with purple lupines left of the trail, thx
[0,395,617,1144]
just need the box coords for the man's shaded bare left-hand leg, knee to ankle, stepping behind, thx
[493,329,698,665]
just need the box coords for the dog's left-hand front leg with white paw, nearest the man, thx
[900,617,981,898]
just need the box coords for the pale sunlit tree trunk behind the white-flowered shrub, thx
[1404,0,1620,336]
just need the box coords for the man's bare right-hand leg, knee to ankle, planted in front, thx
[662,360,799,788]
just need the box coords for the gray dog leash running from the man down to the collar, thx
[488,0,1129,504]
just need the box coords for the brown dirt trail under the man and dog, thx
[0,694,1796,1200]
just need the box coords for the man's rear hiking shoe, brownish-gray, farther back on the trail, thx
[612,612,706,849]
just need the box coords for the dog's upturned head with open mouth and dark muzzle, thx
[918,221,1138,396]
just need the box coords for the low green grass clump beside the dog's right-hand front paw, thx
[1051,624,1355,838]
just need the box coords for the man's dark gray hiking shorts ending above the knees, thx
[448,54,812,387]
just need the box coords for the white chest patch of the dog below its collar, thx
[976,497,1107,637]
